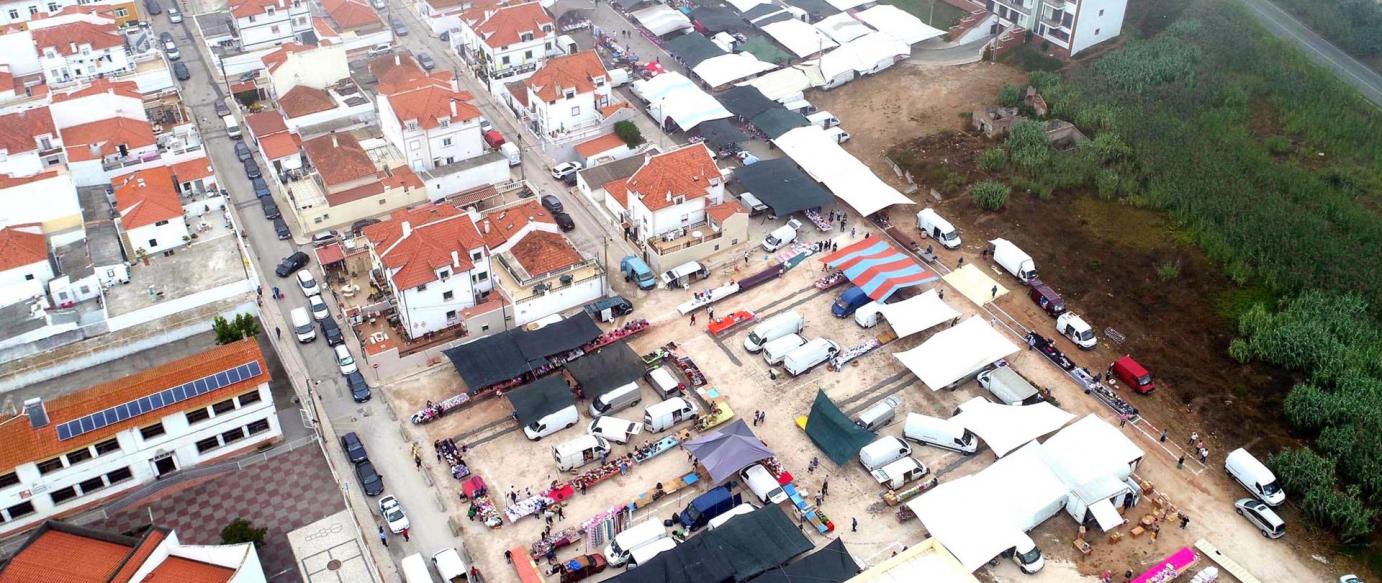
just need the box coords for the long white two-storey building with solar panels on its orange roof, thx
[0,340,282,538]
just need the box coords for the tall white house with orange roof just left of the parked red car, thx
[370,55,485,171]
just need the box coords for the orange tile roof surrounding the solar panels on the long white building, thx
[0,340,269,472]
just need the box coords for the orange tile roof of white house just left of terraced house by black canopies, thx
[365,203,485,289]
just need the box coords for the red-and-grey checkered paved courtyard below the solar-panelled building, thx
[93,446,346,582]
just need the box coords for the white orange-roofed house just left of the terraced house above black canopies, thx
[365,203,493,338]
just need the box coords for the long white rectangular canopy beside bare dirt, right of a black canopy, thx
[773,126,917,216]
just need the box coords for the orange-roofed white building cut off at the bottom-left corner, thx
[0,521,268,583]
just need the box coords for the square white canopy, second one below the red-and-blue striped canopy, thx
[890,316,1017,391]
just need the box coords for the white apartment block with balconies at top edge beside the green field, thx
[988,0,1128,57]
